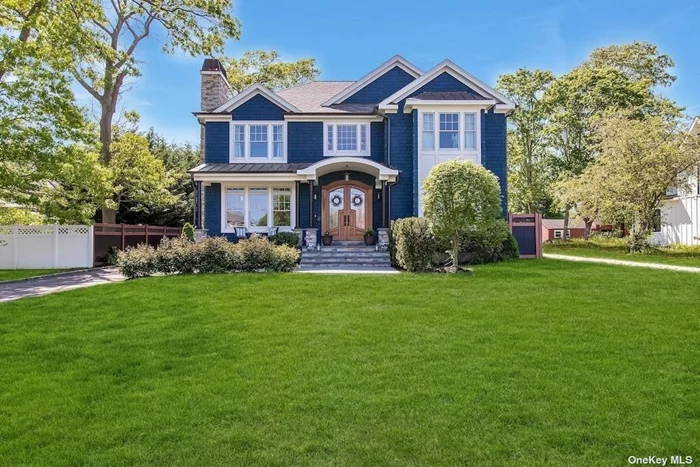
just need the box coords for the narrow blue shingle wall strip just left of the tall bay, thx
[388,113,415,220]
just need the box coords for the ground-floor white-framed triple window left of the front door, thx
[221,185,294,232]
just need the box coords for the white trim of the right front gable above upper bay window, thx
[379,60,515,112]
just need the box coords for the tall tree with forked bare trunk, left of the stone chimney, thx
[68,0,240,222]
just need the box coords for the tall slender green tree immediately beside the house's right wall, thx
[497,68,554,213]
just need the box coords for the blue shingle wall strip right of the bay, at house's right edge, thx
[481,111,508,216]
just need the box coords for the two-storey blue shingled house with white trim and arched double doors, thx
[190,56,515,244]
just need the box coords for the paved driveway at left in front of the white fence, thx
[0,268,124,302]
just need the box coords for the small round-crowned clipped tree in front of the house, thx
[423,160,501,268]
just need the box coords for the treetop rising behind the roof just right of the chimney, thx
[222,50,319,92]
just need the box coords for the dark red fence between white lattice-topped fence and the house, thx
[94,224,182,266]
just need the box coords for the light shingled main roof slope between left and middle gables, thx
[276,81,375,114]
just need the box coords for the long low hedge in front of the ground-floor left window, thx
[117,237,299,278]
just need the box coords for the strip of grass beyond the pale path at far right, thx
[543,241,700,267]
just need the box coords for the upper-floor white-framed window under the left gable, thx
[229,120,287,162]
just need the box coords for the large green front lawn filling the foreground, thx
[0,260,700,466]
